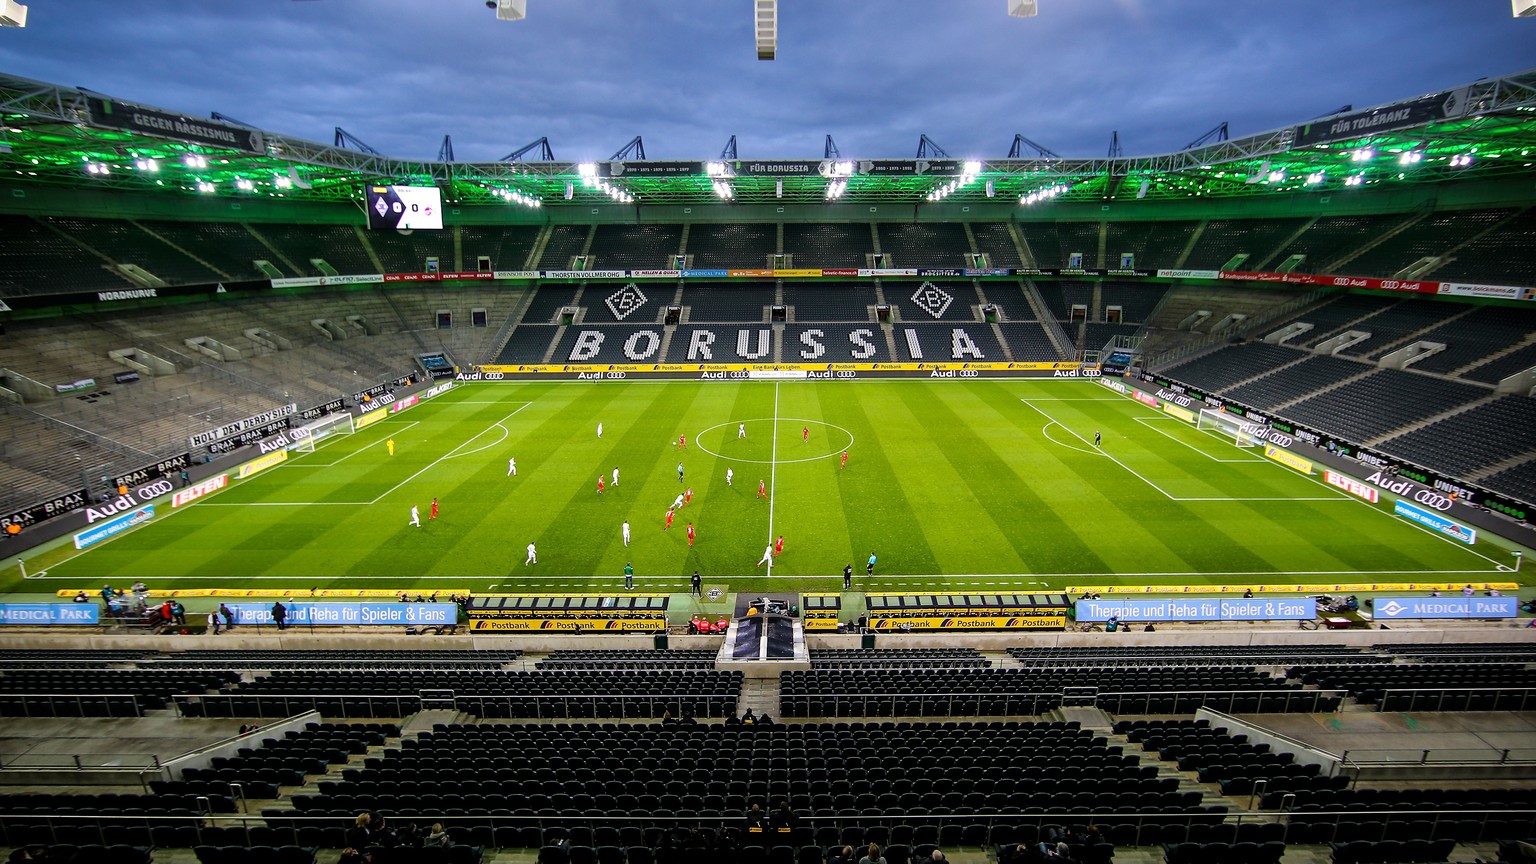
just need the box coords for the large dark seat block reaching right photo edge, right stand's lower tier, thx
[1376,395,1536,477]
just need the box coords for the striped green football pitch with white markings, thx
[9,380,1511,592]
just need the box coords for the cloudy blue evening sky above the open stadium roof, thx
[0,0,1536,160]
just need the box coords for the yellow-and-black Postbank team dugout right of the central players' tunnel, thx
[865,593,1071,632]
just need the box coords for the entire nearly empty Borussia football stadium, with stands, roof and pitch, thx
[0,0,1536,864]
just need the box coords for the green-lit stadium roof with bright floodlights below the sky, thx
[0,69,1536,208]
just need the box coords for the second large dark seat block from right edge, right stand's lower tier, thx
[1284,369,1491,441]
